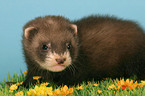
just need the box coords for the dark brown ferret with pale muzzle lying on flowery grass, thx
[22,15,145,87]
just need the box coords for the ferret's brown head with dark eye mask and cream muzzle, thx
[23,16,78,72]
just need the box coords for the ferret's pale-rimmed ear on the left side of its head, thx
[24,27,38,39]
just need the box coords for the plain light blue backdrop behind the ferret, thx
[0,0,145,81]
